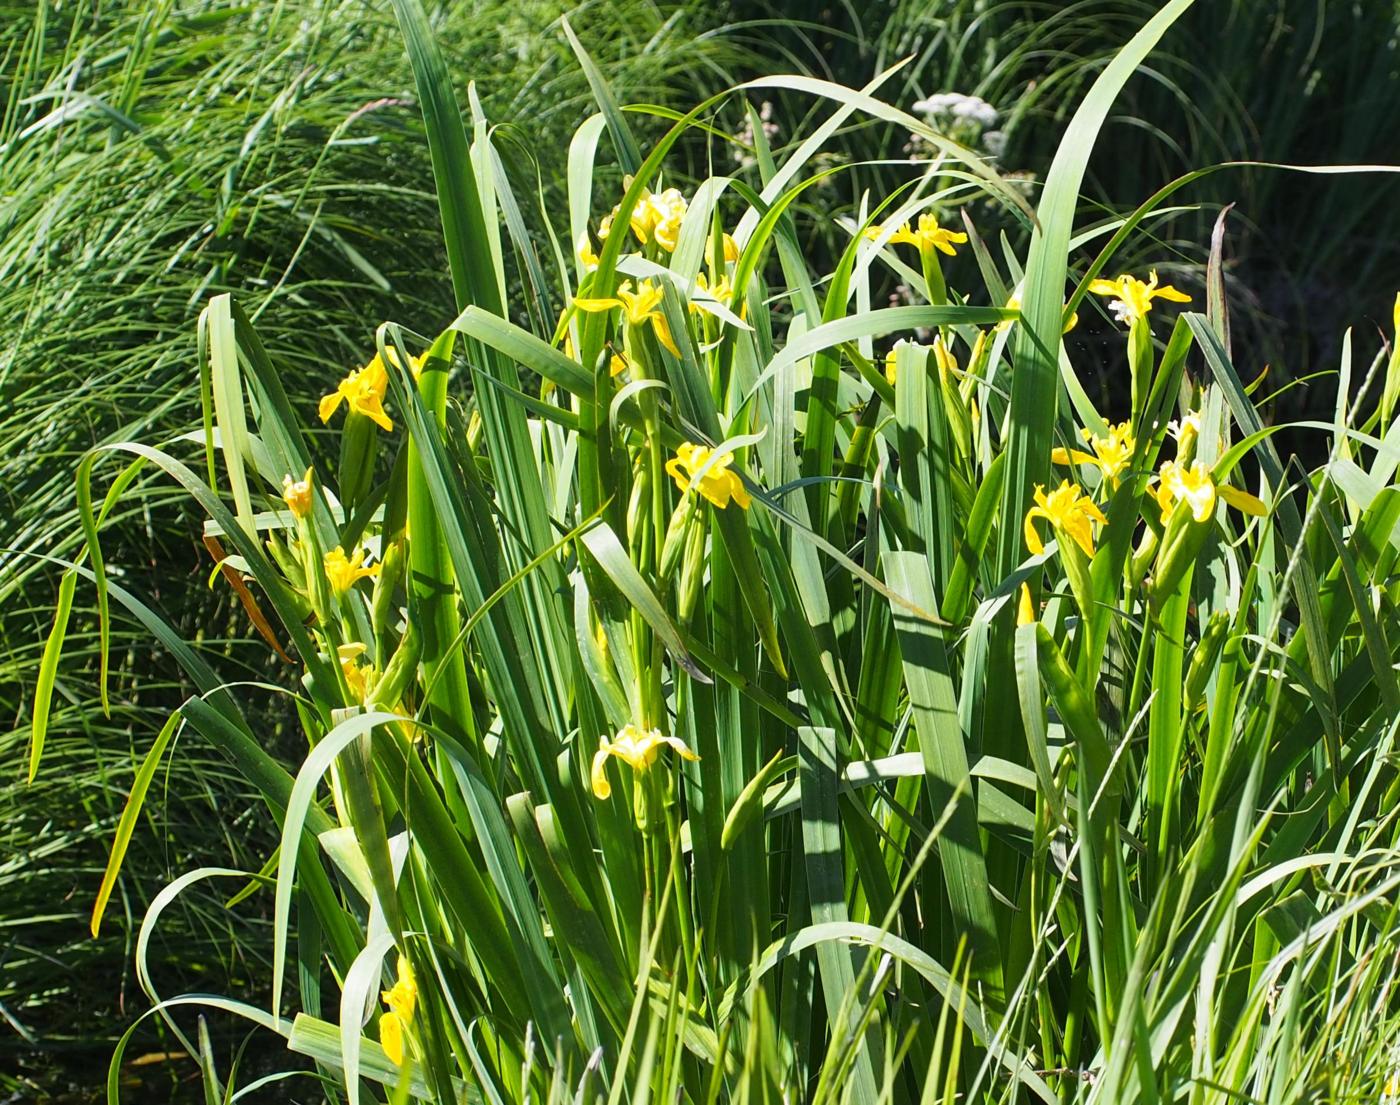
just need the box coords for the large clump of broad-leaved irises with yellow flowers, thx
[24,0,1400,1102]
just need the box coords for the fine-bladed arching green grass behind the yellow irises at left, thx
[0,0,741,1085]
